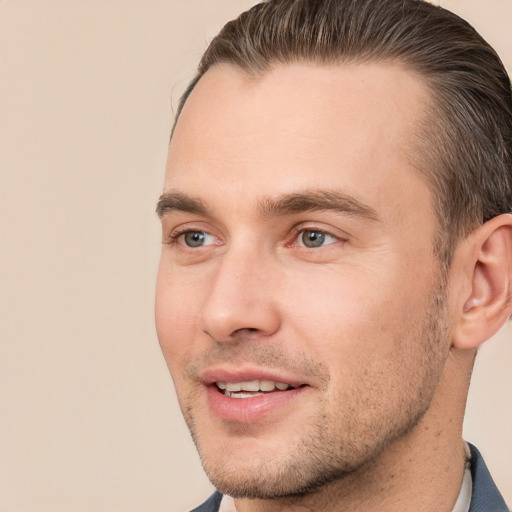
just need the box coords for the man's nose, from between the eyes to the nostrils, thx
[198,246,281,343]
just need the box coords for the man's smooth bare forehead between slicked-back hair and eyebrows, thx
[164,63,428,224]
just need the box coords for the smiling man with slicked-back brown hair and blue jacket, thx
[156,0,512,512]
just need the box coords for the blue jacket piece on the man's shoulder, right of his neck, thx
[468,443,509,512]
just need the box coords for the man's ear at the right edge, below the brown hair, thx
[452,214,512,349]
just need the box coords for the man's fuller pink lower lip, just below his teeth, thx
[206,385,306,423]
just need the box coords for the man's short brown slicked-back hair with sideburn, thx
[175,0,512,268]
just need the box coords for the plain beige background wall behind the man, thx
[0,0,512,512]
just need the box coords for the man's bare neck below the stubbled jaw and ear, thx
[235,350,473,512]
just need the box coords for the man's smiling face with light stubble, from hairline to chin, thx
[156,64,449,498]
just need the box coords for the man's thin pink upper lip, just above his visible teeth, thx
[199,366,308,387]
